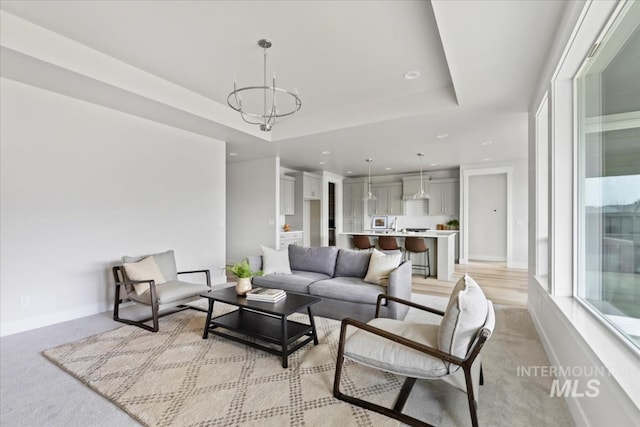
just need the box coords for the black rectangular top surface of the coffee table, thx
[200,286,320,316]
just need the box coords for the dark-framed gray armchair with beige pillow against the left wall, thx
[113,250,211,332]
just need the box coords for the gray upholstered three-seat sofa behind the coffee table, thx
[247,245,411,322]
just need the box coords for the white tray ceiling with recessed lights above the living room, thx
[0,0,566,176]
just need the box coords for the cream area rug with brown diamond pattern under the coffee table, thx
[44,305,402,427]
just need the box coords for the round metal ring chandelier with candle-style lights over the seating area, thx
[227,39,302,132]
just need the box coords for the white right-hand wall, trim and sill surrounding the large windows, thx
[528,1,640,426]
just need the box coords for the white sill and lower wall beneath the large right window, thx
[528,278,640,426]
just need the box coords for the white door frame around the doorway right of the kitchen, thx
[459,166,513,268]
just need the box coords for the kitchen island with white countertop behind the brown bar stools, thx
[339,230,458,280]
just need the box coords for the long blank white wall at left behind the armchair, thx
[0,78,225,335]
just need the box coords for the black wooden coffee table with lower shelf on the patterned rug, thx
[200,286,320,368]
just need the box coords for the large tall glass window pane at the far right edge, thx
[575,2,640,348]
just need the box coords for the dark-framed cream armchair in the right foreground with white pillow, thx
[333,275,495,427]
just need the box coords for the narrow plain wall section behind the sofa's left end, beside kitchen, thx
[227,157,278,263]
